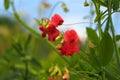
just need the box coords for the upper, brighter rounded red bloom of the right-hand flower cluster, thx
[64,30,80,43]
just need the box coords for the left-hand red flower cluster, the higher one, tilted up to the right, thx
[39,14,63,41]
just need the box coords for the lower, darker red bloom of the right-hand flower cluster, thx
[59,42,79,56]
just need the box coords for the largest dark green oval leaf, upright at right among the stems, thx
[99,32,114,66]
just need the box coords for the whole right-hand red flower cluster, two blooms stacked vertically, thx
[58,30,80,56]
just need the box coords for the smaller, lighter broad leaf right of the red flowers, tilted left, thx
[87,28,99,44]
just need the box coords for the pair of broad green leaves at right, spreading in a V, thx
[87,28,114,66]
